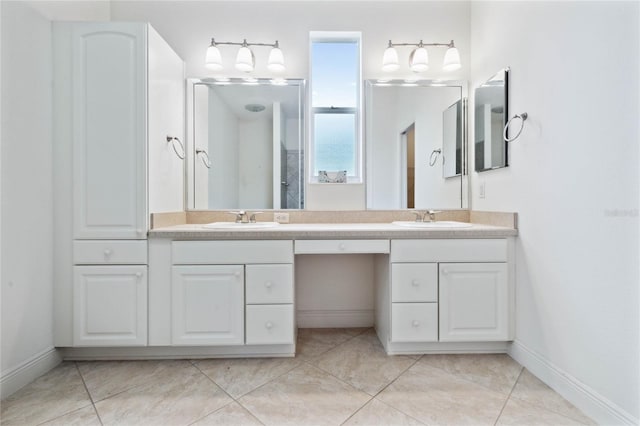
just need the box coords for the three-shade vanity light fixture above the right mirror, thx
[382,40,462,72]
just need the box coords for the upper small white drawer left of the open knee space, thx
[245,264,293,304]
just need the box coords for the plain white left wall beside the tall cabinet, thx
[1,2,53,394]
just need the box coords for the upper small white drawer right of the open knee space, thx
[391,263,438,302]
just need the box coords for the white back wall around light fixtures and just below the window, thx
[111,1,470,210]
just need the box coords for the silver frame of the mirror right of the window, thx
[363,79,471,211]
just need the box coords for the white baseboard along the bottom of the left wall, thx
[0,347,62,399]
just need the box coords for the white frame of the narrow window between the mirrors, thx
[307,31,364,184]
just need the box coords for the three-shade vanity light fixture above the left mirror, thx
[205,38,285,72]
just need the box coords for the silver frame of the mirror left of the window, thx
[184,77,307,211]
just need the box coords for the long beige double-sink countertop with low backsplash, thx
[149,211,518,240]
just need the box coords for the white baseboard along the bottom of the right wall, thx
[508,340,638,425]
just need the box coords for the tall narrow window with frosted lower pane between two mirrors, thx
[309,32,362,182]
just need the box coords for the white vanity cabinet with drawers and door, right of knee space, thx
[376,238,514,353]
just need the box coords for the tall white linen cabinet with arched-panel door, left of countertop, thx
[53,22,184,346]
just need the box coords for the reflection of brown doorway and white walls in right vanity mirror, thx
[365,80,468,209]
